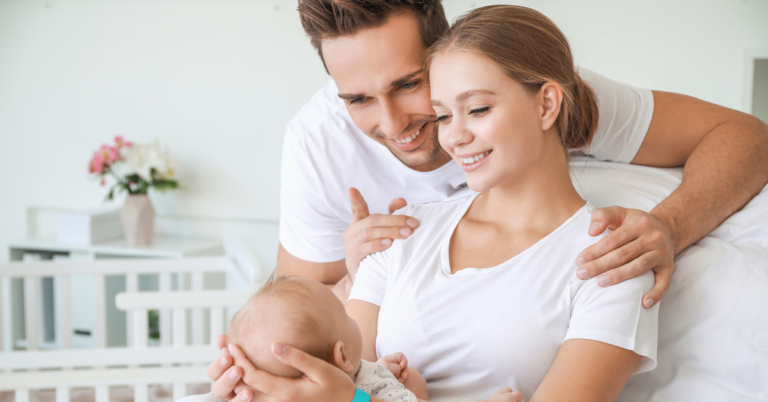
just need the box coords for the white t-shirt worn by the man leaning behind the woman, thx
[280,69,653,262]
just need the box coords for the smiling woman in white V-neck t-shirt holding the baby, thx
[213,6,658,401]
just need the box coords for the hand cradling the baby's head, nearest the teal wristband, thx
[231,343,356,402]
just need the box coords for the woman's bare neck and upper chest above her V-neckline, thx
[469,133,584,233]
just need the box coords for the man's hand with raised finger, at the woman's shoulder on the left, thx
[344,187,419,280]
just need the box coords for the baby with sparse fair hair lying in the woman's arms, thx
[227,277,512,402]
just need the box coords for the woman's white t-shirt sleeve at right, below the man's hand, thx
[565,272,659,374]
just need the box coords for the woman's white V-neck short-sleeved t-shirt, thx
[350,195,658,402]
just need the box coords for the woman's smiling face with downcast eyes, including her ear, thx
[429,50,545,192]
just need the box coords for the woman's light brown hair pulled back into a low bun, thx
[426,5,599,149]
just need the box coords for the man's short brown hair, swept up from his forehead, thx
[298,0,448,71]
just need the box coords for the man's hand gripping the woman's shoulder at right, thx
[576,207,676,308]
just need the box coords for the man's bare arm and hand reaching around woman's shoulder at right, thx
[577,91,768,307]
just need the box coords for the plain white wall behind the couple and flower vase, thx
[0,0,768,262]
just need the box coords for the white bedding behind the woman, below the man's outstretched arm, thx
[571,158,768,402]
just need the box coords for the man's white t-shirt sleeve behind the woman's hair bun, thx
[571,68,653,163]
